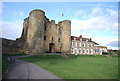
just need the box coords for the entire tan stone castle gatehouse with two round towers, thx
[18,9,71,54]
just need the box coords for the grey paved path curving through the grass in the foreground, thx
[5,60,60,79]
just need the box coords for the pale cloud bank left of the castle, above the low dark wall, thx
[2,20,23,39]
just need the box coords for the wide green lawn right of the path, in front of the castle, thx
[20,55,118,79]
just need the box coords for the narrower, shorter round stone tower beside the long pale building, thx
[61,20,71,53]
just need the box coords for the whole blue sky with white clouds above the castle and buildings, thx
[0,2,118,49]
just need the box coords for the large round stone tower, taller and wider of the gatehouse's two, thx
[27,10,45,53]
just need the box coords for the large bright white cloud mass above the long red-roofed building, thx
[71,4,118,49]
